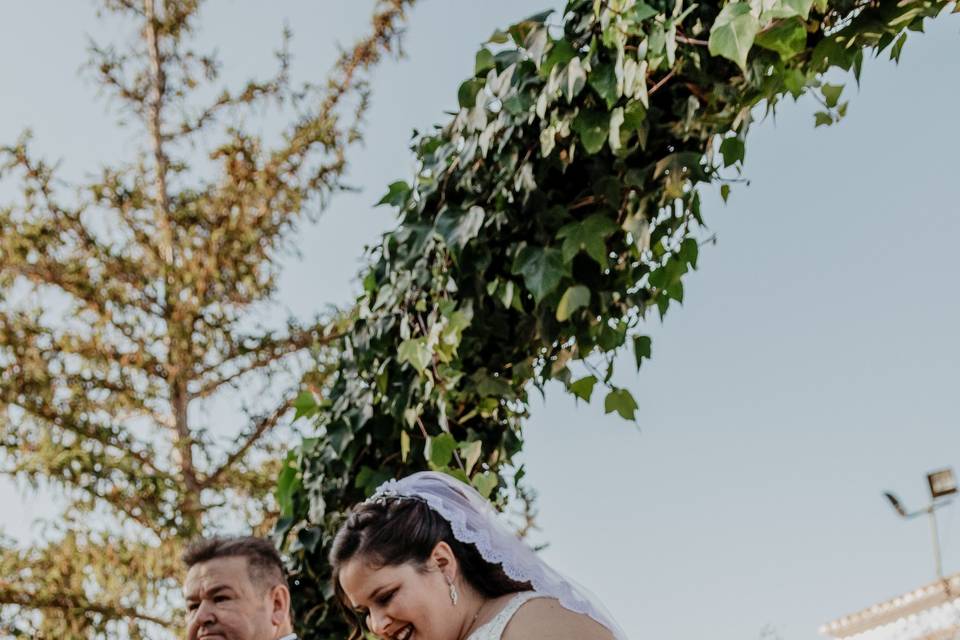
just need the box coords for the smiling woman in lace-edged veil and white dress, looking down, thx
[330,471,626,640]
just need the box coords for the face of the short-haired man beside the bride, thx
[183,556,276,640]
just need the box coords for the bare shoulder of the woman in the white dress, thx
[500,598,613,640]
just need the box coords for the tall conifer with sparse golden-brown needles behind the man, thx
[0,0,413,638]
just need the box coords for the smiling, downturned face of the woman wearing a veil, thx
[340,543,463,640]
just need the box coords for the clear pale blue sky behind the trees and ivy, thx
[0,0,960,640]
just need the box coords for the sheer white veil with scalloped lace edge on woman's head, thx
[370,471,627,640]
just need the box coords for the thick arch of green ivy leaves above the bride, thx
[276,0,956,640]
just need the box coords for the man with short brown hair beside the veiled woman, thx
[183,537,296,640]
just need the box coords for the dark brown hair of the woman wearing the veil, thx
[329,497,532,640]
